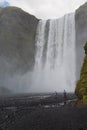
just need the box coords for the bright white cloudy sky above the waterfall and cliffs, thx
[0,0,87,19]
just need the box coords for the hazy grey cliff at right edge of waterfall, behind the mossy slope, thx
[75,3,87,79]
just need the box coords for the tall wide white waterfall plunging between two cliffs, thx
[32,13,76,92]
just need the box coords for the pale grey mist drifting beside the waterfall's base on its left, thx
[0,56,32,95]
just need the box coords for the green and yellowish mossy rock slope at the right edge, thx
[75,43,87,105]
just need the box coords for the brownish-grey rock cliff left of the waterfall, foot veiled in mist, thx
[0,7,38,94]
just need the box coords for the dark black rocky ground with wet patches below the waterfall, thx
[0,95,87,130]
